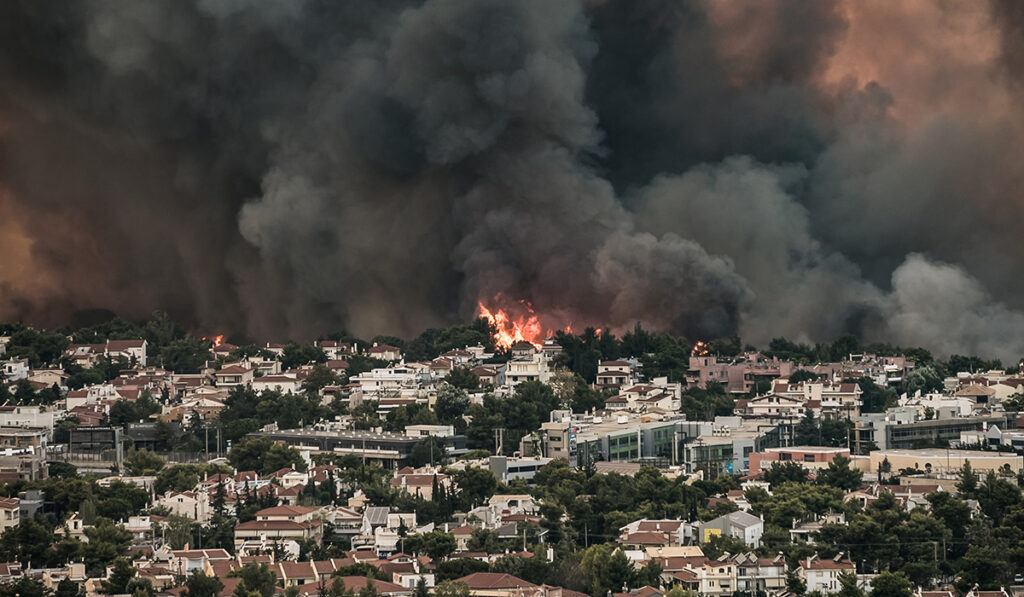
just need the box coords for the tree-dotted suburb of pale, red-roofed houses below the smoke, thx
[0,317,1024,597]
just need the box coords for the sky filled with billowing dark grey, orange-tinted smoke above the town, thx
[0,0,1024,359]
